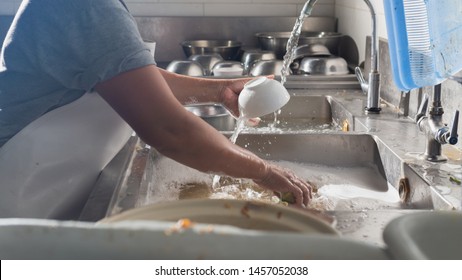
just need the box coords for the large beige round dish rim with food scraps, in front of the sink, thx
[100,199,339,235]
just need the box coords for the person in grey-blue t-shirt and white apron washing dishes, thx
[0,0,311,218]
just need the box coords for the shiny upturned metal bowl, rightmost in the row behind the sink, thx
[299,56,349,75]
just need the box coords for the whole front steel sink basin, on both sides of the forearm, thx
[108,132,412,215]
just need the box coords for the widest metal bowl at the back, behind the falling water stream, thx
[255,32,343,59]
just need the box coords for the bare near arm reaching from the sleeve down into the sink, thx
[95,66,311,206]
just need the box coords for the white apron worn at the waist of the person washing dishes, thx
[0,93,132,219]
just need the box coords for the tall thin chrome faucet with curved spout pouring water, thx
[355,0,381,113]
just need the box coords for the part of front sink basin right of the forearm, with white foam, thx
[230,132,401,210]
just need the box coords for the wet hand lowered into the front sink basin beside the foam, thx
[254,162,313,207]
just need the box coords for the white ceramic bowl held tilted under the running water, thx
[239,77,290,118]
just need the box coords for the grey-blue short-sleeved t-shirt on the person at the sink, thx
[0,0,155,147]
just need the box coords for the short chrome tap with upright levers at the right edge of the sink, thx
[416,84,459,162]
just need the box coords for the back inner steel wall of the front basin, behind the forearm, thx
[236,132,385,168]
